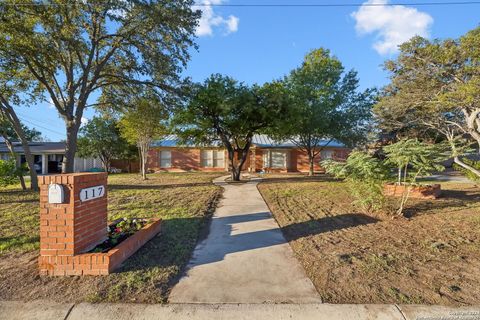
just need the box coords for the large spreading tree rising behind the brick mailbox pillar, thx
[0,0,200,173]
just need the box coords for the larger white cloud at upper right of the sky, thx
[352,0,433,55]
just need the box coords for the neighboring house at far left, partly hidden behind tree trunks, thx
[0,142,102,174]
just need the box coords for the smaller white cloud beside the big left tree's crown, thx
[194,0,240,37]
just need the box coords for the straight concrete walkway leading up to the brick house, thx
[169,177,321,303]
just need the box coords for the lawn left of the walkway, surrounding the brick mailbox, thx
[0,173,224,302]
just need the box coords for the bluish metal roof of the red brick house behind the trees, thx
[151,134,345,148]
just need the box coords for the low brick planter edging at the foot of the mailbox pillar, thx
[39,218,162,276]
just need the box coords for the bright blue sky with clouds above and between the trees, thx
[13,0,480,141]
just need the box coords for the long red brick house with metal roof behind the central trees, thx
[147,135,351,172]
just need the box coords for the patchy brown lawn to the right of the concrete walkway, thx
[259,175,480,305]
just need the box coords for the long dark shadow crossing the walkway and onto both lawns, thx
[119,212,379,278]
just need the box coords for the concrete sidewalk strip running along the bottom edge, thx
[0,301,480,320]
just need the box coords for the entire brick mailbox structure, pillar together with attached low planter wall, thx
[38,173,161,276]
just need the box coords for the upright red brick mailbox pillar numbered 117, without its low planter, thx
[39,173,107,274]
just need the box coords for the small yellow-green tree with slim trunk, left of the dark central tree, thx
[118,95,169,180]
